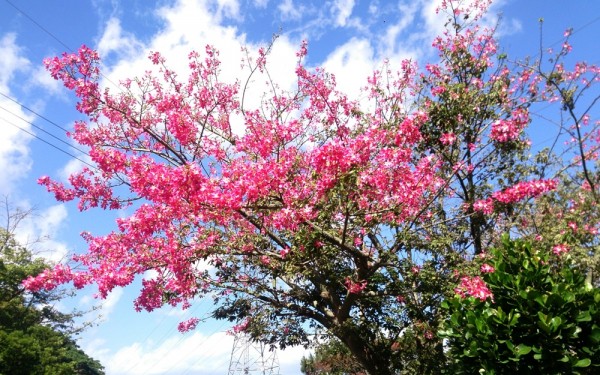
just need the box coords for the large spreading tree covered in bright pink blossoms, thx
[26,1,595,374]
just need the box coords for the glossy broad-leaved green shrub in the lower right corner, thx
[439,236,600,374]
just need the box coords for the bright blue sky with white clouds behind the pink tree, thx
[0,0,600,375]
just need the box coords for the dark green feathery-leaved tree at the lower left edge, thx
[0,229,104,375]
